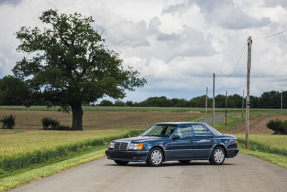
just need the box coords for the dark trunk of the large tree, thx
[71,103,84,131]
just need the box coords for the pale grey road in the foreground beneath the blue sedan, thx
[12,154,287,192]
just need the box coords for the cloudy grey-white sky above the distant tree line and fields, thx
[0,0,287,102]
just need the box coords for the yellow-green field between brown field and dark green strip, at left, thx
[0,129,129,157]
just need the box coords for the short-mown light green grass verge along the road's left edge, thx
[0,145,107,192]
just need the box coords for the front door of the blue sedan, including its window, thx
[166,125,196,160]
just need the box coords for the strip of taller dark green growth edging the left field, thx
[0,131,143,174]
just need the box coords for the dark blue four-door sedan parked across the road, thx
[106,122,239,166]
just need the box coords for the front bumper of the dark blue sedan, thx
[106,150,148,162]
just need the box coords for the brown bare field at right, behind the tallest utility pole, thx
[225,116,287,134]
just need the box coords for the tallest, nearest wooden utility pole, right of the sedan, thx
[245,36,252,149]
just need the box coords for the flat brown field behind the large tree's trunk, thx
[0,110,200,130]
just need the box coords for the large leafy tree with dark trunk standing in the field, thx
[13,10,146,130]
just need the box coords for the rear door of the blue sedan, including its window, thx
[192,124,215,159]
